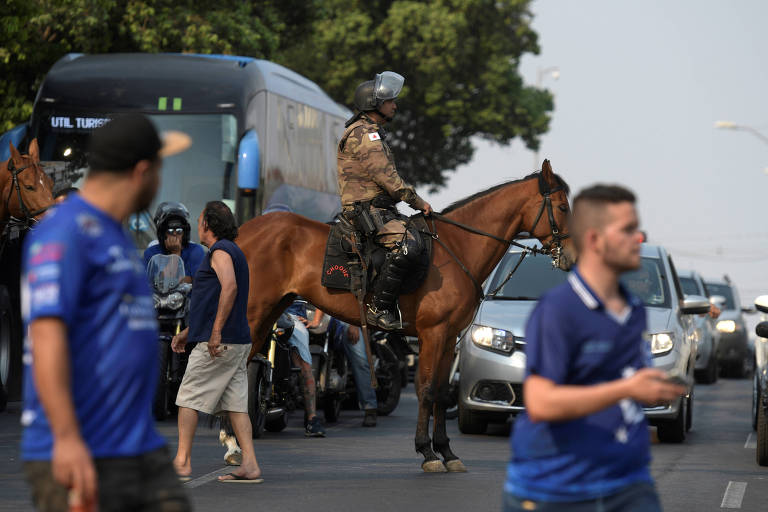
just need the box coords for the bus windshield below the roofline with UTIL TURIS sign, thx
[37,112,238,249]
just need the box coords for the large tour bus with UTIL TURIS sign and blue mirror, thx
[0,53,351,408]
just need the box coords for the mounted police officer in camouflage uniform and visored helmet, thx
[337,71,432,330]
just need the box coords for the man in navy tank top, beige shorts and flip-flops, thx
[171,201,263,483]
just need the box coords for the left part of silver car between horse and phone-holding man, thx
[458,240,568,434]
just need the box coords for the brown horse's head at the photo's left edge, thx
[0,139,53,225]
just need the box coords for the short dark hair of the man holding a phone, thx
[569,184,635,252]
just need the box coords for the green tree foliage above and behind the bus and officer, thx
[0,0,553,186]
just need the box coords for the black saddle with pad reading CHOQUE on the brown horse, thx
[321,213,432,295]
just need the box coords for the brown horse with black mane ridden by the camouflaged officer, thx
[237,160,572,472]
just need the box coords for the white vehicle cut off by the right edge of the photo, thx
[752,295,768,466]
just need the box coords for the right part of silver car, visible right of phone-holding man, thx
[621,244,709,443]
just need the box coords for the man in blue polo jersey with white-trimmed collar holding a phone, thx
[504,185,685,512]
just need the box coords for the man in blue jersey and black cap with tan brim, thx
[21,114,189,511]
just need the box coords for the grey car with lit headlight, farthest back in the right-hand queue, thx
[706,277,753,378]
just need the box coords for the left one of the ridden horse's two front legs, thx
[415,340,446,473]
